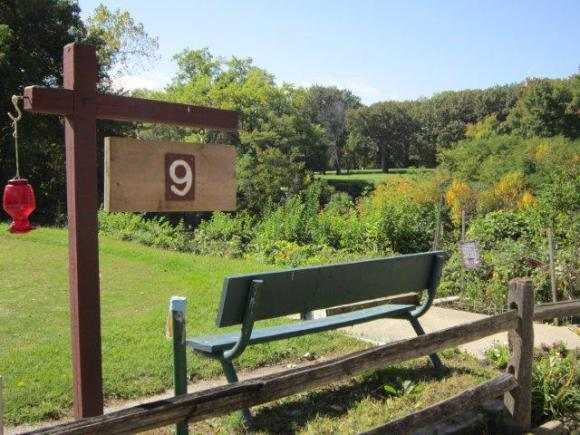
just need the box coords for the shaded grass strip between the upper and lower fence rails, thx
[187,350,498,434]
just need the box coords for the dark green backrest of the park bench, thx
[216,251,445,327]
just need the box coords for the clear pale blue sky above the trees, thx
[79,0,580,104]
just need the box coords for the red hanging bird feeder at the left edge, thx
[2,178,36,233]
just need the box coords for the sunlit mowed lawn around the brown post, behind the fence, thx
[0,224,366,425]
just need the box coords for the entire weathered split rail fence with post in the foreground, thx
[26,278,580,434]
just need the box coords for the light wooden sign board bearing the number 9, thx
[105,137,236,212]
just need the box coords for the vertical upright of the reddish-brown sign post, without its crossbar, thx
[63,43,103,418]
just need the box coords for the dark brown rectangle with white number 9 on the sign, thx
[165,153,195,201]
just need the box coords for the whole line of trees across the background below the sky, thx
[0,0,580,222]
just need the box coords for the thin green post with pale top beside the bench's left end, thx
[169,296,188,435]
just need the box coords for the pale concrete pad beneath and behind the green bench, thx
[343,307,580,358]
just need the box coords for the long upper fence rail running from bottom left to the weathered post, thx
[26,311,518,434]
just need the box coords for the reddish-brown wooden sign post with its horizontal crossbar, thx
[24,43,239,418]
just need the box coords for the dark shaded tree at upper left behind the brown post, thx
[0,0,159,223]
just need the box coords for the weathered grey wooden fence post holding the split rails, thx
[504,278,534,431]
